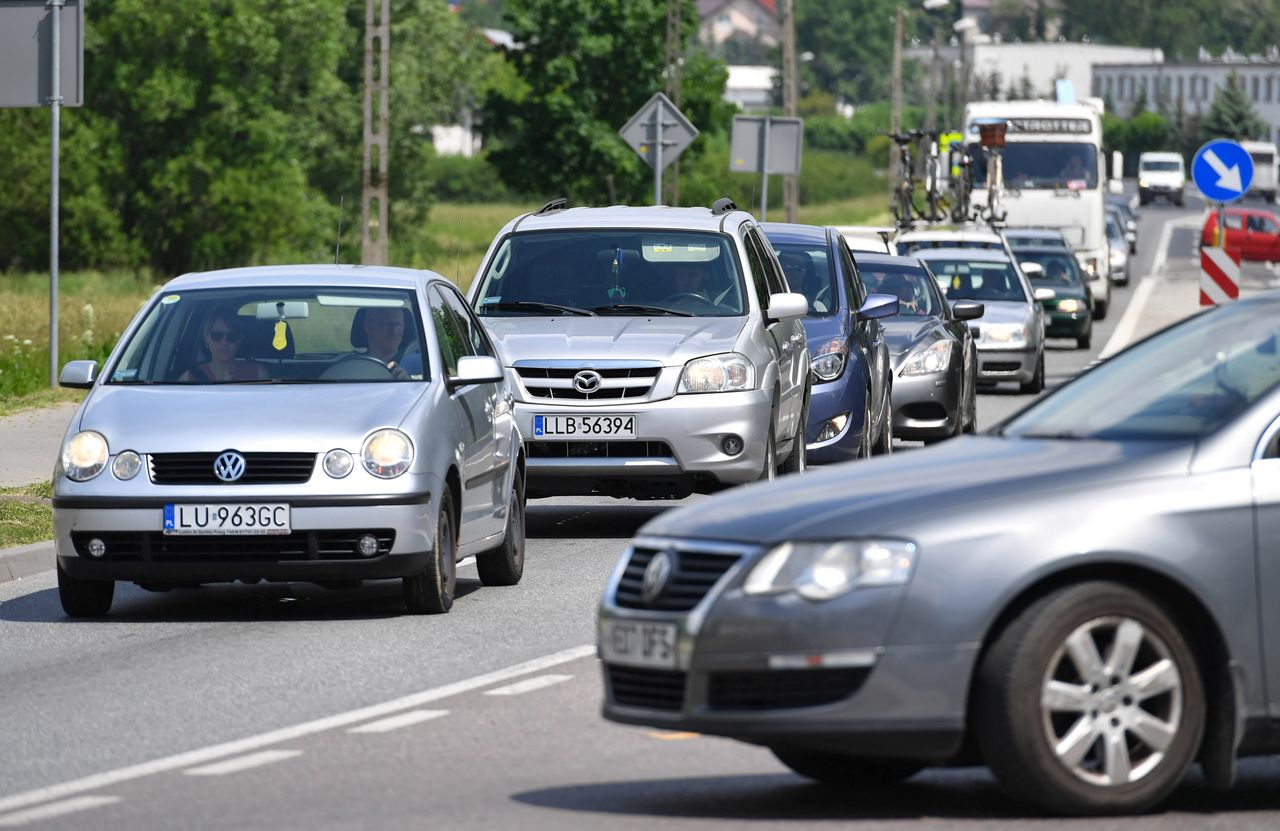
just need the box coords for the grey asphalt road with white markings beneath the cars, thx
[0,190,1280,831]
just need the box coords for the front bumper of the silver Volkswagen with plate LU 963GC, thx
[54,493,435,583]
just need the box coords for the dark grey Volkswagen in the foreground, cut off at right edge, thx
[599,292,1280,813]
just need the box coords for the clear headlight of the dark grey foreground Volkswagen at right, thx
[742,539,916,601]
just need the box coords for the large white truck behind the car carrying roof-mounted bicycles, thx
[964,101,1111,320]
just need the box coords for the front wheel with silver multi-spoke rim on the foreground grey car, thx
[974,581,1204,814]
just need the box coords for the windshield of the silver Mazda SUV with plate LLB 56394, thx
[475,228,748,316]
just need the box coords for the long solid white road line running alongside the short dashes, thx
[0,644,595,812]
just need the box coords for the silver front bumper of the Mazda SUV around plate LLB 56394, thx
[516,389,773,496]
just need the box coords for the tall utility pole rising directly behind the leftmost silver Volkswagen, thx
[360,0,392,265]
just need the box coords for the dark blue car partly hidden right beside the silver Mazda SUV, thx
[762,223,897,464]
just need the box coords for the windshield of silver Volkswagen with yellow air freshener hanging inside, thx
[106,286,428,384]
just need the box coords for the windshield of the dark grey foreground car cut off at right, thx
[1004,299,1280,439]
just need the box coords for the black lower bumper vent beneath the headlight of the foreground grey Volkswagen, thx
[707,668,870,709]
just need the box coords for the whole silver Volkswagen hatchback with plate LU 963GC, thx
[54,265,525,617]
